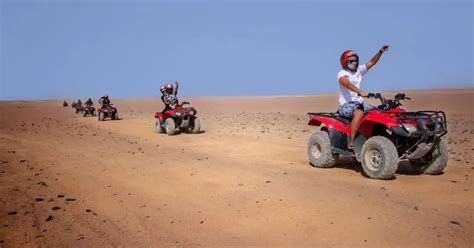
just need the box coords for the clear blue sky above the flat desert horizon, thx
[0,0,474,99]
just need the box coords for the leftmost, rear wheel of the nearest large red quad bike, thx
[307,131,337,168]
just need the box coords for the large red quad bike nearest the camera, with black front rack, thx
[307,93,448,179]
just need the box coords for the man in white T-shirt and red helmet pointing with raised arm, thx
[337,45,390,148]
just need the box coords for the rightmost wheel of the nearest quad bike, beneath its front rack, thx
[410,140,448,175]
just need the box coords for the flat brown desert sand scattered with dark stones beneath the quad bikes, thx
[0,88,474,247]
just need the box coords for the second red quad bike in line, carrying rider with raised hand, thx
[155,102,201,135]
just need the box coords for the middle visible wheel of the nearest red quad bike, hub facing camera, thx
[361,136,399,179]
